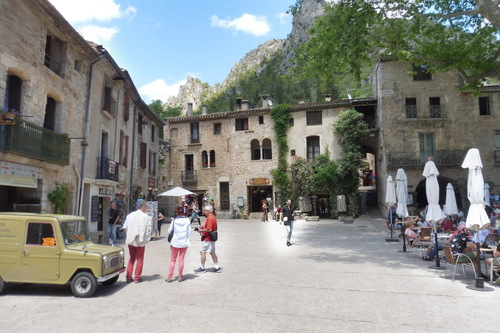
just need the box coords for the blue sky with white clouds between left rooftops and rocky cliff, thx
[49,0,295,103]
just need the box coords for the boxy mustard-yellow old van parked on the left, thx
[0,213,125,297]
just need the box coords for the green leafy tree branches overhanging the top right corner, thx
[297,0,500,86]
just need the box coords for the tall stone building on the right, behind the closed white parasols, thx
[373,59,500,213]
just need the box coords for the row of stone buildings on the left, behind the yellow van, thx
[0,0,163,239]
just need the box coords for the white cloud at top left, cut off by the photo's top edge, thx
[49,0,137,25]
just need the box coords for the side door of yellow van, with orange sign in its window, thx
[20,221,61,283]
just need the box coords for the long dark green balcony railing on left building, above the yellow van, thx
[0,118,70,165]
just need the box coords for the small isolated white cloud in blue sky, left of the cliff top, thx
[210,13,271,37]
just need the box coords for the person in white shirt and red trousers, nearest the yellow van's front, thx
[123,201,152,283]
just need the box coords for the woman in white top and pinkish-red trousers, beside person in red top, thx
[165,207,191,282]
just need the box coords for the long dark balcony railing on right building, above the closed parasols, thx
[387,150,467,167]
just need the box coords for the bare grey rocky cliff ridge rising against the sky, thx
[166,0,326,114]
